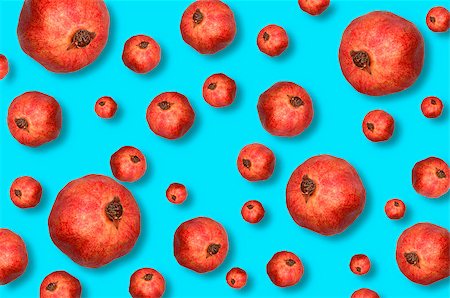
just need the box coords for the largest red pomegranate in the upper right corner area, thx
[339,11,424,96]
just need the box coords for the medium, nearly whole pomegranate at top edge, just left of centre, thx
[180,0,236,54]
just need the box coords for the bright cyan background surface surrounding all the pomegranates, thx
[0,0,450,297]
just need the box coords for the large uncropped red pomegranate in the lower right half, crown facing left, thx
[286,155,366,236]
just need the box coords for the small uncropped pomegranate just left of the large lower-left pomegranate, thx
[9,176,42,208]
